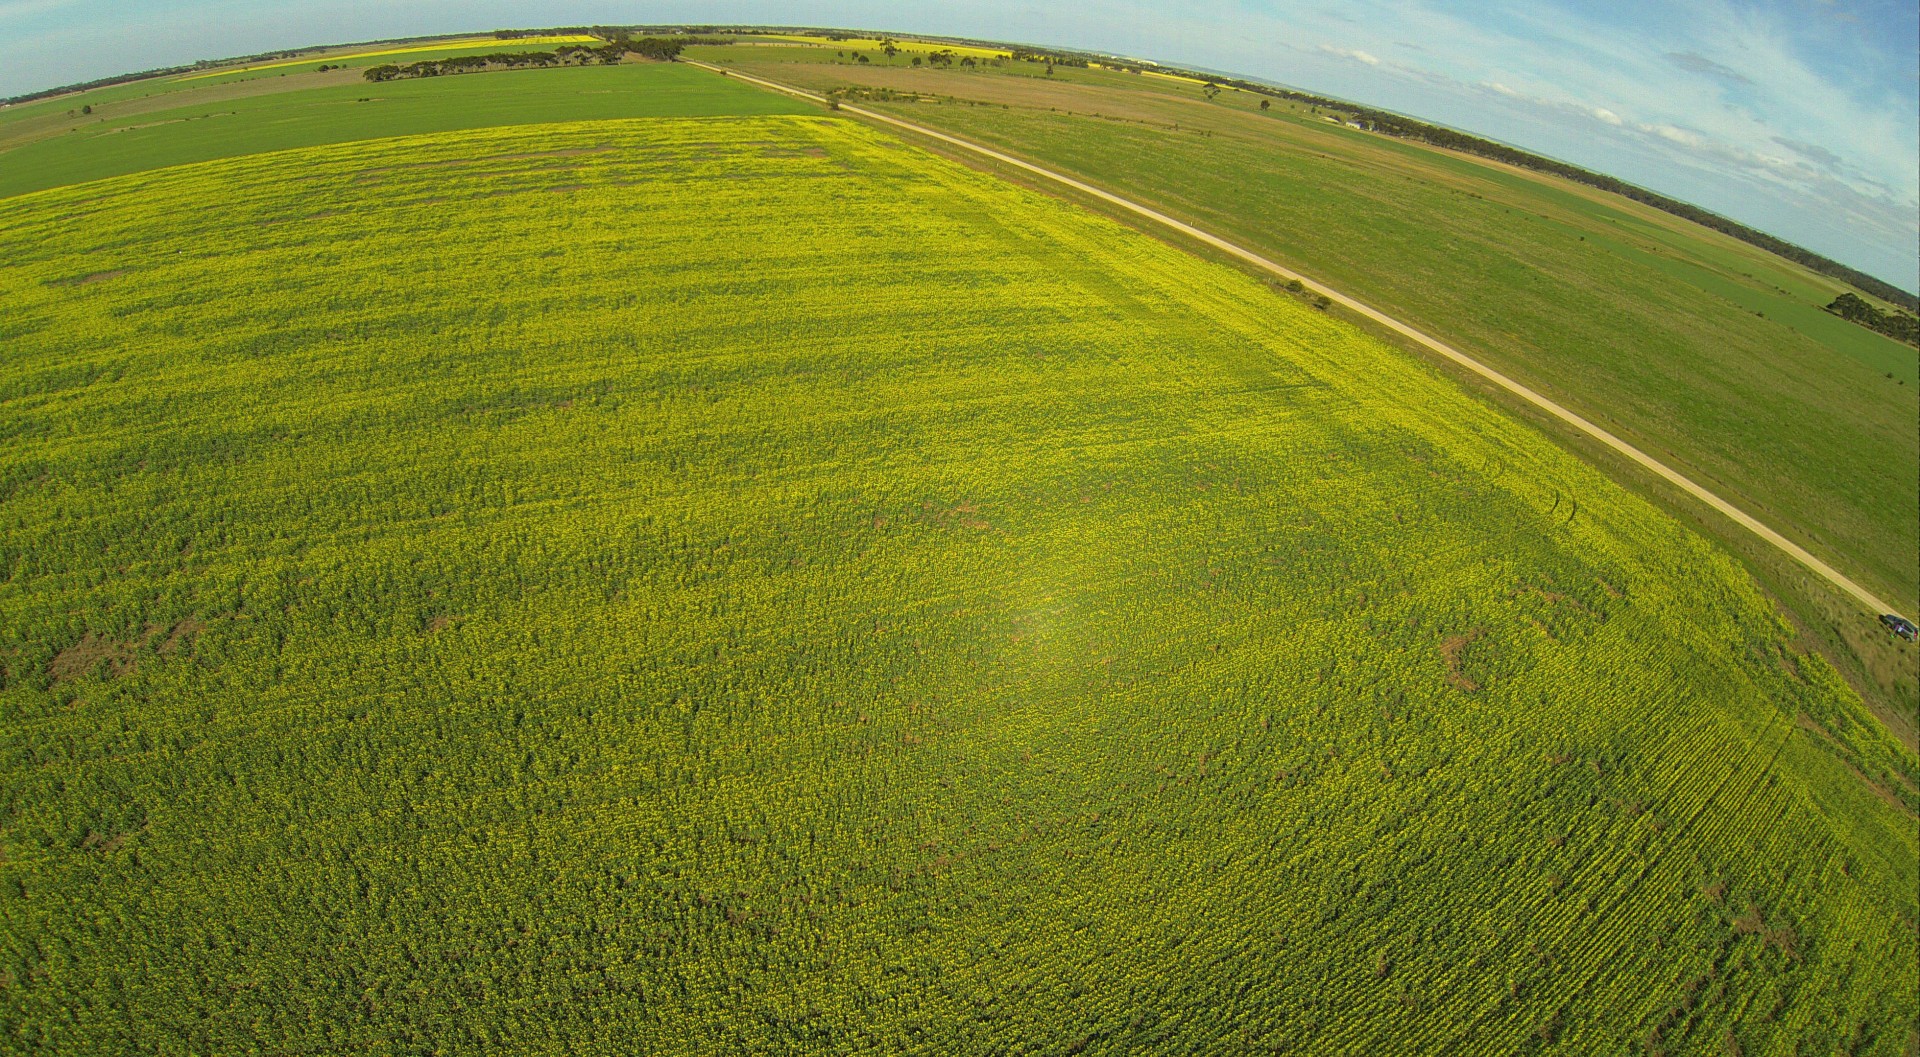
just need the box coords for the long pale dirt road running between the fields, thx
[682,59,1897,616]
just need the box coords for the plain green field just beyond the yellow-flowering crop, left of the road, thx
[0,59,814,196]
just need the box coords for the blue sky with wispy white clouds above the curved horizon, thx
[0,0,1920,290]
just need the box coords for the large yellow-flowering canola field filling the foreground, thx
[0,115,1920,1055]
